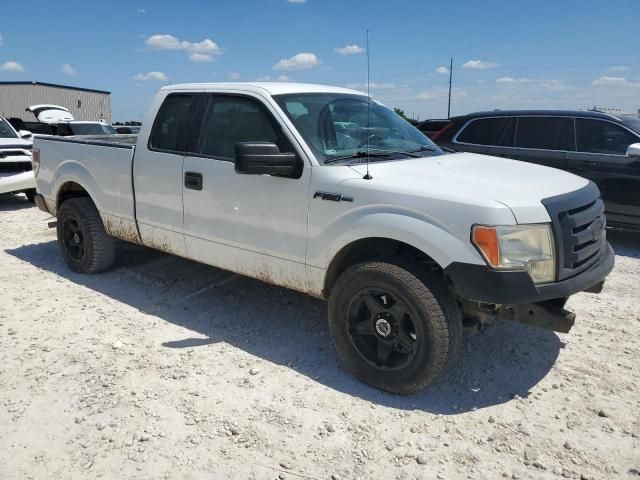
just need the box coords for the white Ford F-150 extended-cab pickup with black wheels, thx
[34,83,614,393]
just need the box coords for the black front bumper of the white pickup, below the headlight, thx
[444,242,615,305]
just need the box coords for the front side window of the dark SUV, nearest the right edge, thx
[576,118,638,155]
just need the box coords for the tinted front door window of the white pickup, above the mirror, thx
[198,96,292,159]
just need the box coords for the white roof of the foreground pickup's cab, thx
[162,82,364,95]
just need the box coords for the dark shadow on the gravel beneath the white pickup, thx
[7,241,563,415]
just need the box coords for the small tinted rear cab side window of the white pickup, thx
[149,94,193,152]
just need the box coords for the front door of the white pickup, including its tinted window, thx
[183,94,311,291]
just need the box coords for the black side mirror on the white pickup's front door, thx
[235,142,301,178]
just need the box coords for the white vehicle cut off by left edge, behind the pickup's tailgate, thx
[0,117,36,200]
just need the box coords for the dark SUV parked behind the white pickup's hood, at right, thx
[432,110,640,230]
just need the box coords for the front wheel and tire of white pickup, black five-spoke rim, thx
[329,261,462,394]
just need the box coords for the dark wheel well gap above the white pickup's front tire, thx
[322,238,442,298]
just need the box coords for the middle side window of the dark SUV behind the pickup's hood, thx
[516,117,571,150]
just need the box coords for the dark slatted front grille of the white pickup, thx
[542,182,607,280]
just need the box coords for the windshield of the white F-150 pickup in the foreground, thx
[274,93,442,163]
